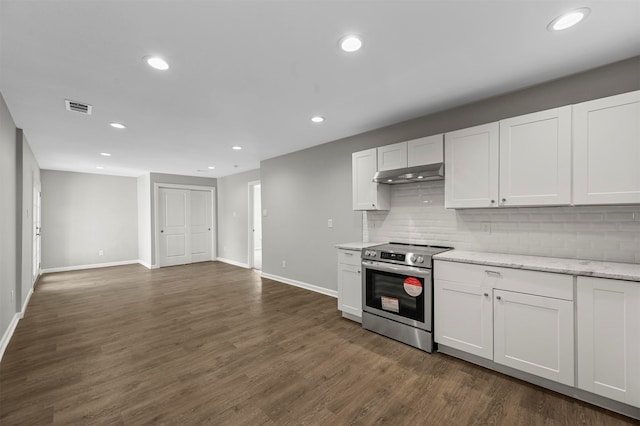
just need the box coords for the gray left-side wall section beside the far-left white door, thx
[16,129,40,309]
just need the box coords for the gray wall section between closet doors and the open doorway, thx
[218,170,260,266]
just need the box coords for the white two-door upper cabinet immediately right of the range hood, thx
[445,106,571,208]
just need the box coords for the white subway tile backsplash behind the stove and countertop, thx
[363,181,640,263]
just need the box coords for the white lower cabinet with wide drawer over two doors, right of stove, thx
[433,261,575,386]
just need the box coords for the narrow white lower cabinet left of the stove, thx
[338,249,362,319]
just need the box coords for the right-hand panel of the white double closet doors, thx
[189,191,212,262]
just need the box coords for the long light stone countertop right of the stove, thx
[433,250,640,283]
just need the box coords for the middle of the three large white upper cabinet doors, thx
[499,106,571,206]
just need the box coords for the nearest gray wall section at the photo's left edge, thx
[0,94,18,342]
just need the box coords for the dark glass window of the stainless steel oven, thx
[365,269,425,322]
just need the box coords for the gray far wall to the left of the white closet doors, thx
[41,170,138,269]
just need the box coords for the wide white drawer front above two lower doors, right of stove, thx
[433,261,574,300]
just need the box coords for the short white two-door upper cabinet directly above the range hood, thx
[378,134,443,172]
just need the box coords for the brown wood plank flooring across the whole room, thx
[0,262,638,426]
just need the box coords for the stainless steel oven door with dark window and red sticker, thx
[362,260,433,330]
